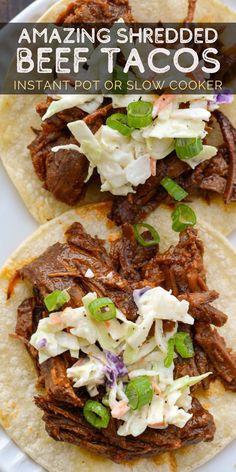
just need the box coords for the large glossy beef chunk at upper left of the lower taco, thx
[19,223,137,319]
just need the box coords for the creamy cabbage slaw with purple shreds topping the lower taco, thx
[30,286,210,437]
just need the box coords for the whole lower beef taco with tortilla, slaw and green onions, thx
[0,202,236,472]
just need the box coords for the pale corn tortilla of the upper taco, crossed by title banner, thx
[0,0,236,230]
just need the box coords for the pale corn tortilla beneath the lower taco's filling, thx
[0,202,236,472]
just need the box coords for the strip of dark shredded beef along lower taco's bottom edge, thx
[35,397,215,463]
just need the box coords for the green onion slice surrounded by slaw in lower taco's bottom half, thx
[125,375,153,410]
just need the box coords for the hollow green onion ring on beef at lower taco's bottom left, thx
[83,400,110,429]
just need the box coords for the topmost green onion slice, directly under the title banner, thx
[127,100,153,128]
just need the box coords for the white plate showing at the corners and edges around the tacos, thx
[0,0,236,472]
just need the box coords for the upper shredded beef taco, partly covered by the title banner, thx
[0,0,236,230]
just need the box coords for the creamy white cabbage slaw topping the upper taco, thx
[46,95,227,195]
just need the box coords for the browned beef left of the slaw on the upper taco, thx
[29,100,116,205]
